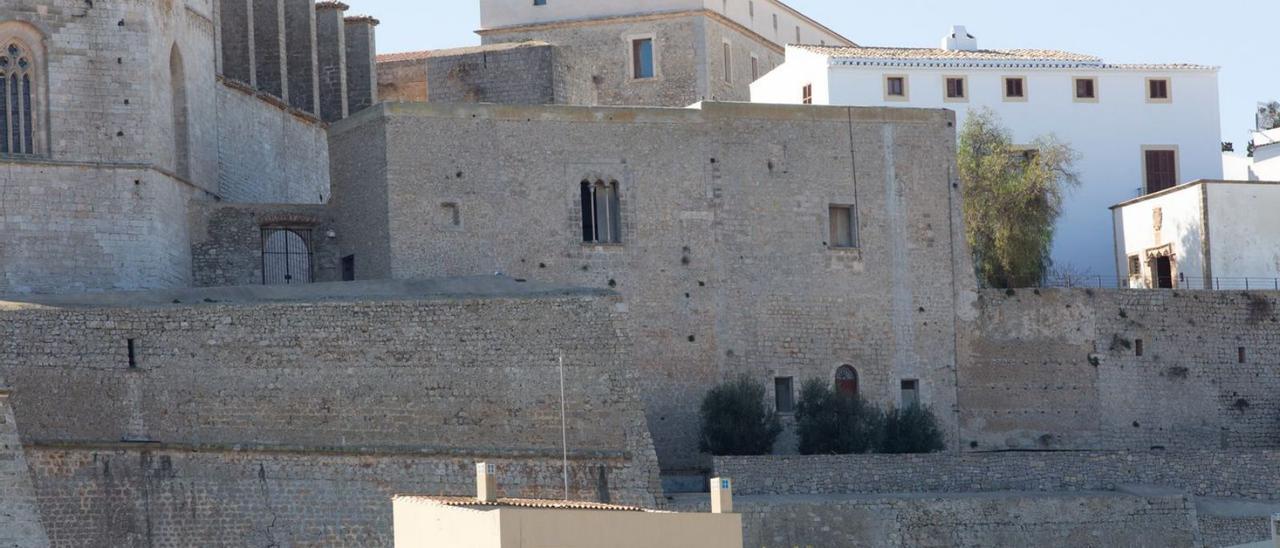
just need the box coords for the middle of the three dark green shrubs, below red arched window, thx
[796,379,884,455]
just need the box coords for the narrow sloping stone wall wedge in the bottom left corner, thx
[0,385,49,548]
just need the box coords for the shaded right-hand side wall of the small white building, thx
[1207,182,1280,289]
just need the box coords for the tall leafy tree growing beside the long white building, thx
[957,109,1079,288]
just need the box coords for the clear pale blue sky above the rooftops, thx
[347,0,1280,151]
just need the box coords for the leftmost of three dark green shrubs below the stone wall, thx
[700,376,782,456]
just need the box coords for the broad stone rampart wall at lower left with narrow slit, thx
[0,289,658,545]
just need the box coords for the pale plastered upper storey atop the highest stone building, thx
[480,0,852,45]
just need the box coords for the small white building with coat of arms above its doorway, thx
[1111,181,1280,289]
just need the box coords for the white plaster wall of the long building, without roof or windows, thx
[751,47,1222,275]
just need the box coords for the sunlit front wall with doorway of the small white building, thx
[1112,186,1206,289]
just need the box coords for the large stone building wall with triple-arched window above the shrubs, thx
[332,104,972,469]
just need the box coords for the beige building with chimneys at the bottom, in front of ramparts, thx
[393,497,742,548]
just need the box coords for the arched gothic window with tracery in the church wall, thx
[0,40,38,155]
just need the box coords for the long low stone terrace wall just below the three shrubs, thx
[716,449,1280,501]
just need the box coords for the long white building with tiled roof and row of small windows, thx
[751,27,1222,277]
